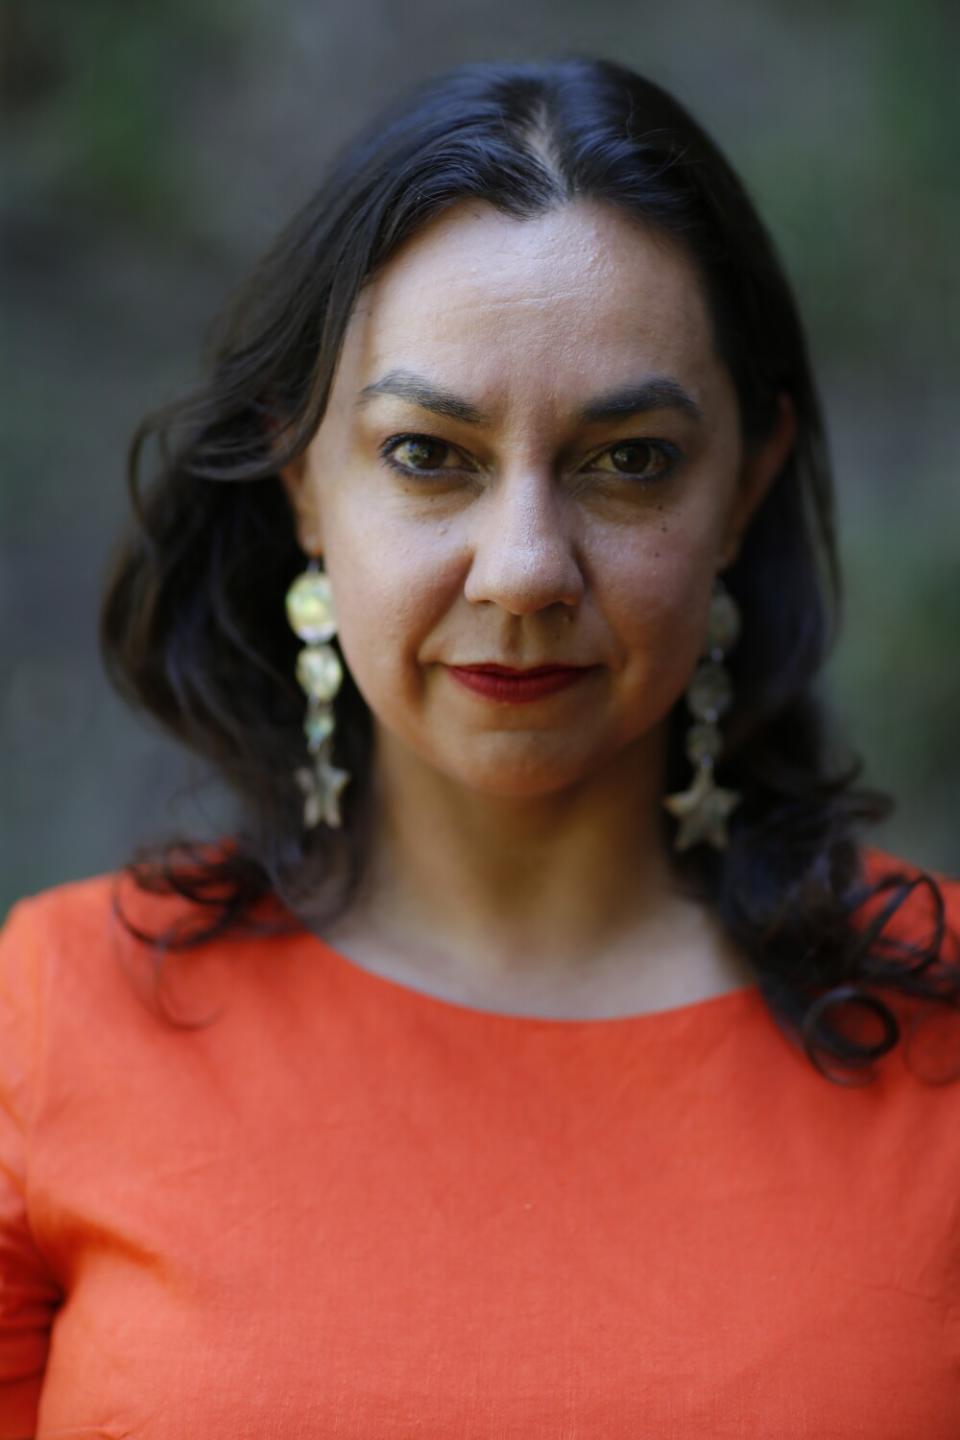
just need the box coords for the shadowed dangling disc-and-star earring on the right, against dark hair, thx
[664,576,743,850]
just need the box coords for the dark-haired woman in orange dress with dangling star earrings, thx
[0,59,960,1440]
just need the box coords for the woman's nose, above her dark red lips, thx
[463,472,584,615]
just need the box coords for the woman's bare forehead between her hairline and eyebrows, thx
[340,202,718,403]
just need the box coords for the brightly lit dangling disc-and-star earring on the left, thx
[286,557,350,829]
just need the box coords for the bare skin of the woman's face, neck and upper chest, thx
[284,202,794,1018]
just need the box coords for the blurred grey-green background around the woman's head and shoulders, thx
[0,0,960,913]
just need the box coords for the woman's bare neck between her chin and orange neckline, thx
[346,720,687,978]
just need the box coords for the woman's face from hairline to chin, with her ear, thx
[285,202,792,796]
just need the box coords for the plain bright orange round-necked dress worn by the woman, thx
[0,846,960,1440]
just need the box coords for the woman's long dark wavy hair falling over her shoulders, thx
[101,56,960,1083]
